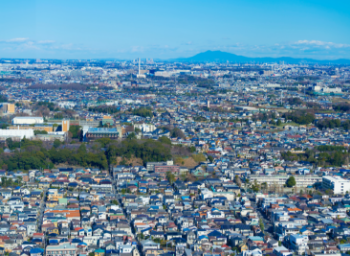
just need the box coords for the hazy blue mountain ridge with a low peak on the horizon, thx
[171,51,350,64]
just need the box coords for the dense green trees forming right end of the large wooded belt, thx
[106,139,172,163]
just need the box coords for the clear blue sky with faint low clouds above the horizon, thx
[0,0,350,59]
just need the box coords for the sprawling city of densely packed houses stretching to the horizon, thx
[0,59,350,256]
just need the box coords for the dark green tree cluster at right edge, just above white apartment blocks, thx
[281,145,350,166]
